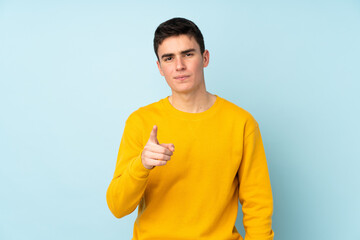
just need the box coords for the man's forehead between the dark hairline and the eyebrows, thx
[158,34,200,56]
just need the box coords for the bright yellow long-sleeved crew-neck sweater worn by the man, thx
[106,96,274,240]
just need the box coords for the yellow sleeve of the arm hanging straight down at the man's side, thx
[238,122,274,240]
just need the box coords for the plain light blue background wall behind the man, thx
[0,0,360,240]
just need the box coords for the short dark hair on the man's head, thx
[154,17,205,60]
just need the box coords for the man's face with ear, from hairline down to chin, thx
[157,35,209,94]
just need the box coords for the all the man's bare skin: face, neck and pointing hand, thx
[141,35,216,169]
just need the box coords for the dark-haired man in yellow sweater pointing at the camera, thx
[106,18,274,240]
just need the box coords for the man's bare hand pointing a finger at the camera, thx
[141,125,175,169]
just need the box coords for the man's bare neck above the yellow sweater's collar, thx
[169,90,216,113]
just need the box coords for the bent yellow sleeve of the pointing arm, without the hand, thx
[106,115,150,218]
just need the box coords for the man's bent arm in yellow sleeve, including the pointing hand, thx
[106,115,175,218]
